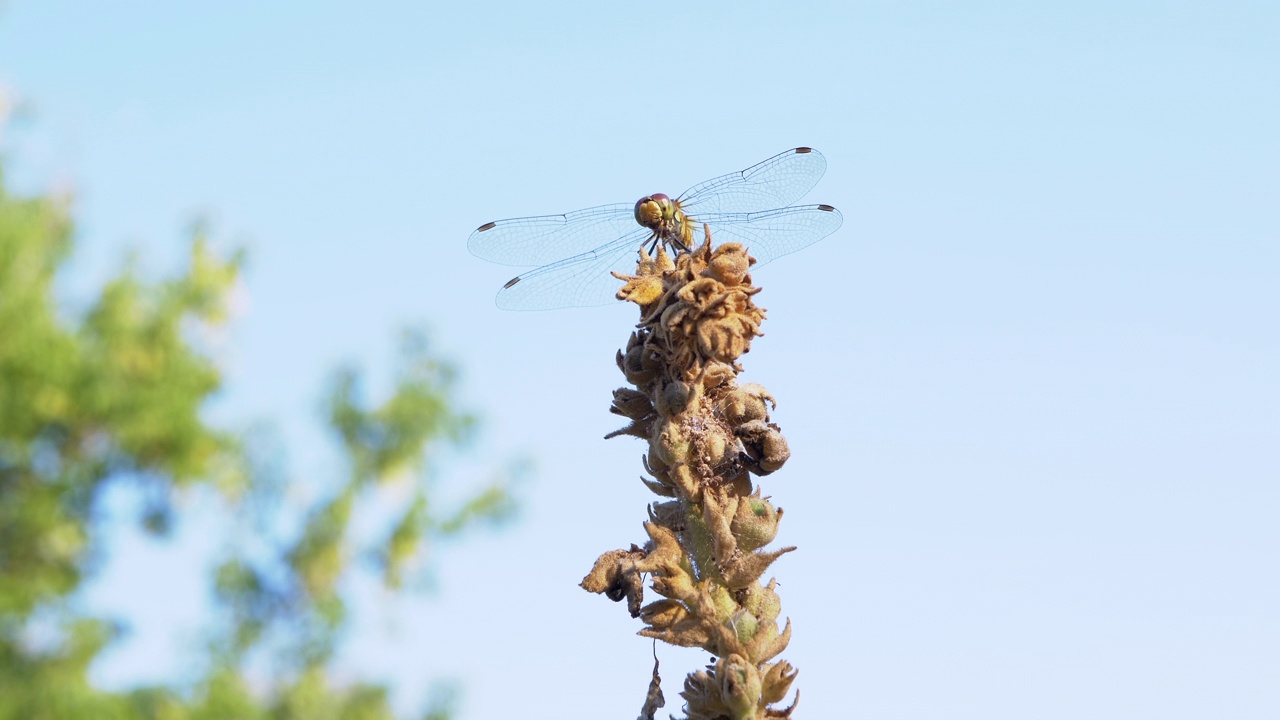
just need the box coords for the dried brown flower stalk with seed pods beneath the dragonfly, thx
[582,229,799,720]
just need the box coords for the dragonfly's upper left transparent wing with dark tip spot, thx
[467,204,639,265]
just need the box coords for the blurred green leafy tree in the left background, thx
[0,159,512,720]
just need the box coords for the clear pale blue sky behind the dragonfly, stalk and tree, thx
[0,0,1280,720]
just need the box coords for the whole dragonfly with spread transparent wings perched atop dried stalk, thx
[467,147,844,310]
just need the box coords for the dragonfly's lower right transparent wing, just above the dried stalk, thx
[694,205,845,265]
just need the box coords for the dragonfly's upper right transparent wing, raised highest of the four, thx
[680,147,827,215]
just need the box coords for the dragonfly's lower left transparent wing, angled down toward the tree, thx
[497,227,652,310]
